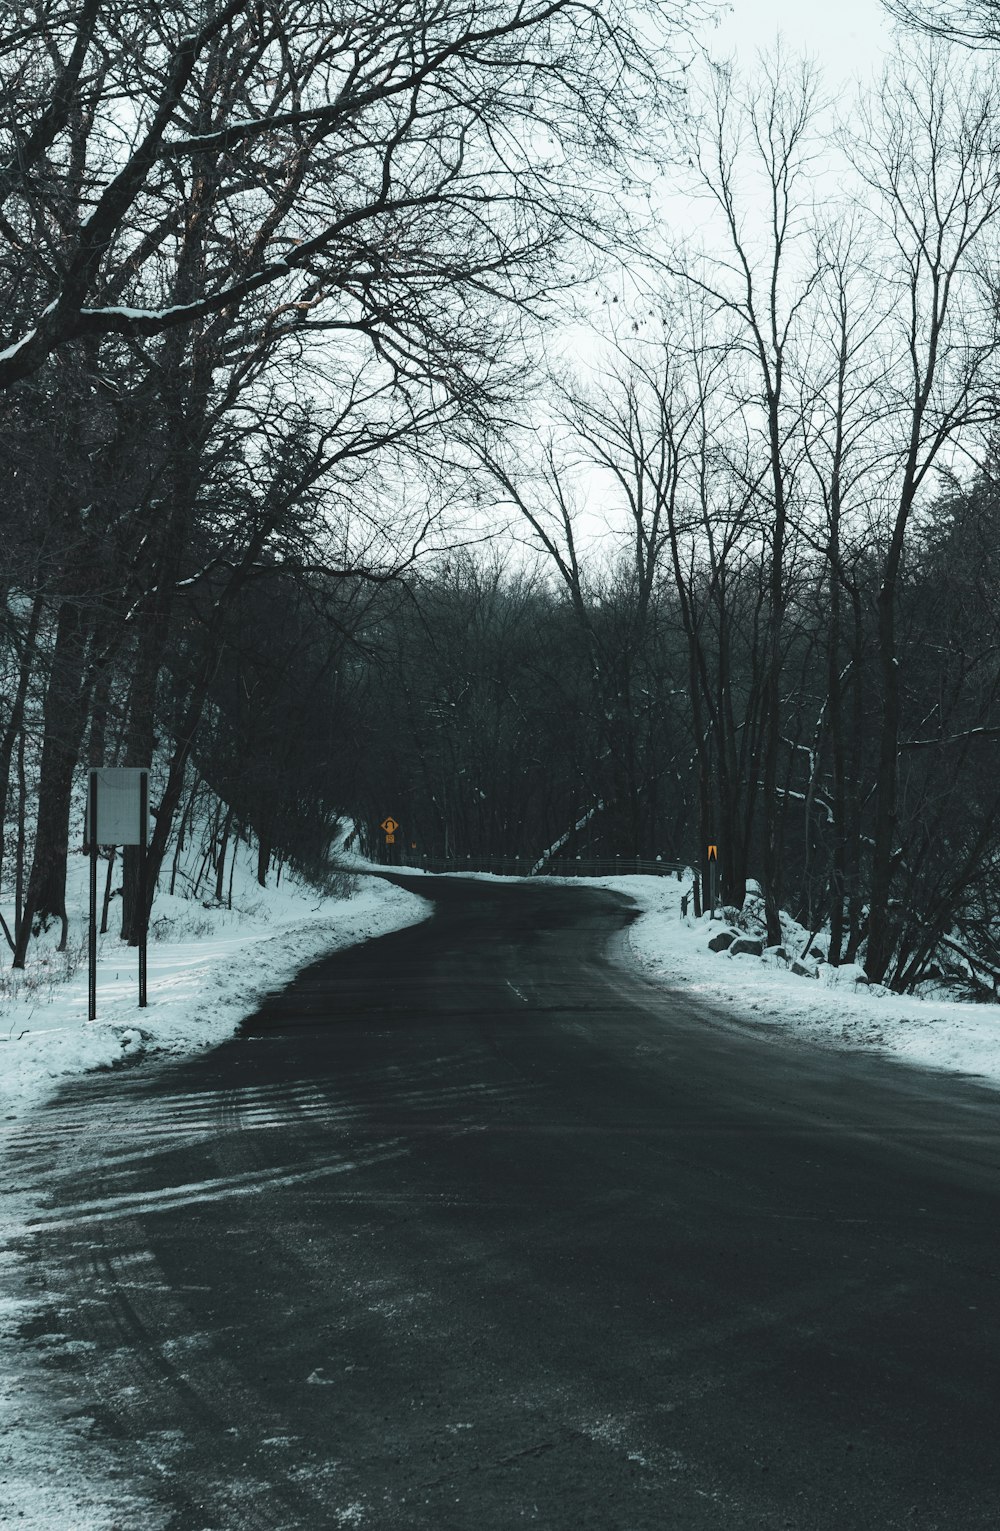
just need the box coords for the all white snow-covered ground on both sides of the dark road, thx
[0,856,1000,1531]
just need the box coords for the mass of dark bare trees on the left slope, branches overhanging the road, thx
[0,0,692,966]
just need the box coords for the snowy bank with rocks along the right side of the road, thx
[600,877,1000,1084]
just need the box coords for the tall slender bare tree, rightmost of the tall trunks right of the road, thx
[853,46,1000,981]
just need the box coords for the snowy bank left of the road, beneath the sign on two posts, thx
[0,848,432,1119]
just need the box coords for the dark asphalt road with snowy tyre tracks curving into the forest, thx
[6,877,1000,1531]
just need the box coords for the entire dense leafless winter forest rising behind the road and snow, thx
[0,0,1000,989]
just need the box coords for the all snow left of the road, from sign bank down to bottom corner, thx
[0,847,432,1531]
